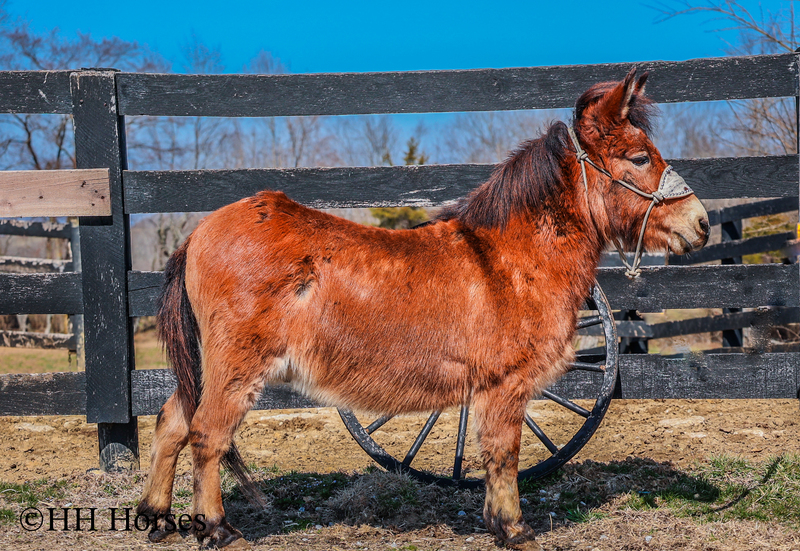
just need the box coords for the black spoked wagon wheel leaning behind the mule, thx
[339,284,618,488]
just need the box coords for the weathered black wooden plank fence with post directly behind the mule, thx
[0,54,800,469]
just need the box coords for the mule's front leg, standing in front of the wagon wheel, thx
[473,381,540,550]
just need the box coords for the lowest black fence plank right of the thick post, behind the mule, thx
[131,353,800,415]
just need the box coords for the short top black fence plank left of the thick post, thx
[0,71,72,114]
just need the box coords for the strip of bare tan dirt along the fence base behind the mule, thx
[0,400,800,482]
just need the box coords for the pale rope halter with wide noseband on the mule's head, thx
[567,126,694,279]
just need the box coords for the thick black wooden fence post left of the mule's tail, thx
[70,69,139,471]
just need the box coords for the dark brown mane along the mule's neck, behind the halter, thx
[436,121,569,228]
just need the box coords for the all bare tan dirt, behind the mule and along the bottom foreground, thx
[0,400,800,551]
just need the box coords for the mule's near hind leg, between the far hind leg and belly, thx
[189,347,264,547]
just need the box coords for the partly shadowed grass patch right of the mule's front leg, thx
[520,455,800,528]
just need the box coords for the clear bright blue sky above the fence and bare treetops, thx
[6,0,788,73]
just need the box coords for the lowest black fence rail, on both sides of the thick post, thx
[0,353,800,416]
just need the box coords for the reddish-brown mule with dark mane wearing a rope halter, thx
[138,70,709,548]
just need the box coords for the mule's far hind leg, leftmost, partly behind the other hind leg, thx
[136,392,189,542]
